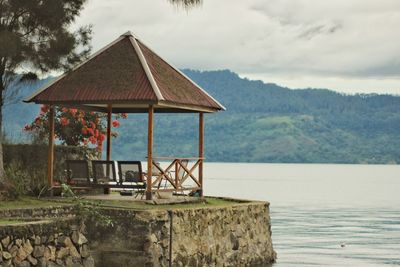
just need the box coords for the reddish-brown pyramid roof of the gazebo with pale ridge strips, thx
[25,32,225,113]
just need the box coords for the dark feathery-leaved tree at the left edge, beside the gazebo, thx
[0,0,91,187]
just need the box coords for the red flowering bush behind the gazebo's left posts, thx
[24,105,127,151]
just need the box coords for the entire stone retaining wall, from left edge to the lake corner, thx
[0,202,276,267]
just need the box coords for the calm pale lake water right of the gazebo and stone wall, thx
[204,163,400,267]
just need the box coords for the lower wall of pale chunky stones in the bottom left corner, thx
[0,219,94,267]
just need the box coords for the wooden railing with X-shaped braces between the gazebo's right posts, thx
[152,157,203,193]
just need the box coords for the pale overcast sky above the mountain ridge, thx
[73,0,400,95]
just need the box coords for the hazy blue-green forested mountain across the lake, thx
[4,70,400,164]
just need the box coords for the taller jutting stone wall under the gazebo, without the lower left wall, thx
[88,202,276,267]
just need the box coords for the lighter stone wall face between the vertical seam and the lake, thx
[167,203,276,266]
